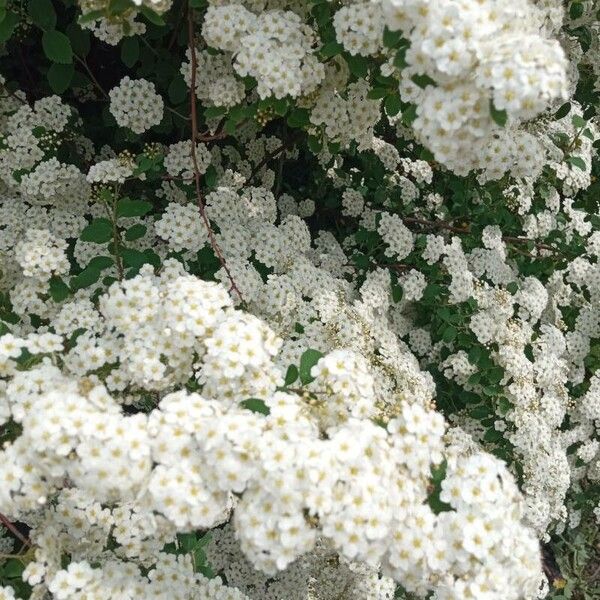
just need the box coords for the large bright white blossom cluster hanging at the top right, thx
[381,0,567,177]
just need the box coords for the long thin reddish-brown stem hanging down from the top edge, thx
[187,2,244,302]
